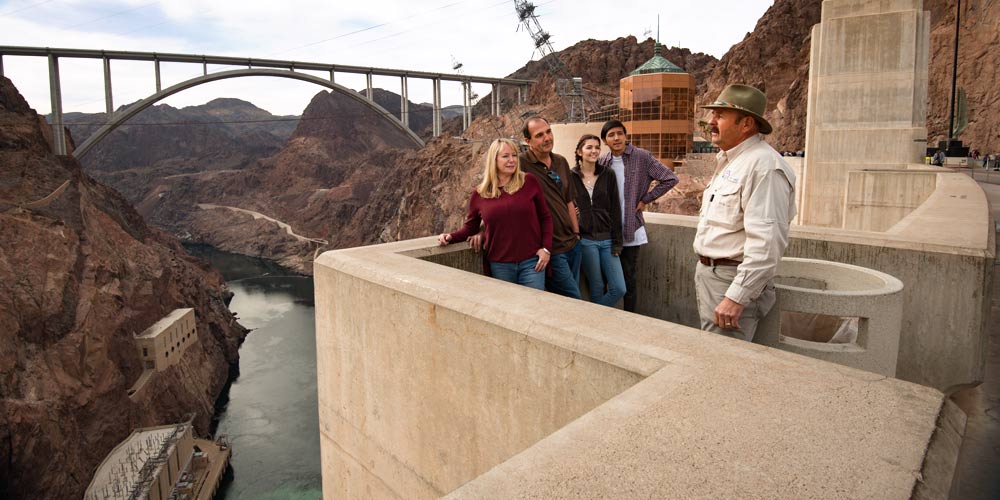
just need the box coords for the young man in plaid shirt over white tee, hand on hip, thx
[597,120,678,312]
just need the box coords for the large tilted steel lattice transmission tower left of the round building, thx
[514,0,597,122]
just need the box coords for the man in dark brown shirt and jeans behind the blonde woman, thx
[521,116,580,299]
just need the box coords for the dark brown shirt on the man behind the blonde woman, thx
[521,149,579,254]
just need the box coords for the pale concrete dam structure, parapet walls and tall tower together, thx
[314,0,996,500]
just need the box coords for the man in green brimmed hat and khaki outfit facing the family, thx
[694,85,795,341]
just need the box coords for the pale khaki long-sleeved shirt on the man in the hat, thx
[694,135,796,305]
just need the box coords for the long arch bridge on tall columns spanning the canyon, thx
[0,46,534,158]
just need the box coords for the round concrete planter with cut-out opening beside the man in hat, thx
[754,257,903,376]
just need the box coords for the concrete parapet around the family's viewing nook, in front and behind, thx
[315,235,964,499]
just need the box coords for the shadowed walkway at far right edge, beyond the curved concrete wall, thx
[951,181,1000,500]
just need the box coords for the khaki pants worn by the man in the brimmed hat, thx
[694,262,775,341]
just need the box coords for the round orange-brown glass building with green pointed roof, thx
[619,43,695,161]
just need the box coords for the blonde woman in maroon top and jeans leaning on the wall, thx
[438,139,552,290]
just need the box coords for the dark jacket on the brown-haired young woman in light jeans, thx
[571,165,623,254]
